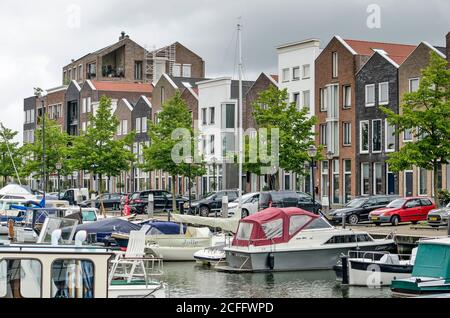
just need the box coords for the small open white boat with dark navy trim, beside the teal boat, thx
[333,248,417,288]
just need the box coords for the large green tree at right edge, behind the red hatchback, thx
[381,52,450,205]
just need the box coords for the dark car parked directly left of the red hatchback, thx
[327,195,399,224]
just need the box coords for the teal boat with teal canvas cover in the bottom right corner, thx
[391,238,450,296]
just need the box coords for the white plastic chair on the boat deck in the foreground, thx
[110,231,147,284]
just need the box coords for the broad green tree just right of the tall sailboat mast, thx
[245,86,317,189]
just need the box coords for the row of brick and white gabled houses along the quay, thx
[24,33,450,202]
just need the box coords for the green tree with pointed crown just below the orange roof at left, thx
[70,96,135,213]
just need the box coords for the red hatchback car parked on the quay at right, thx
[369,197,436,226]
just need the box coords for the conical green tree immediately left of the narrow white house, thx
[142,92,205,211]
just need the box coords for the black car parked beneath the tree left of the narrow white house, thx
[129,190,188,214]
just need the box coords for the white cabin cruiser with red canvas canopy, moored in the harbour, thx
[220,208,396,272]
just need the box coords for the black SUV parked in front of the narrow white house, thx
[188,190,239,217]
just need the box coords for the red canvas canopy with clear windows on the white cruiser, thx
[233,208,319,246]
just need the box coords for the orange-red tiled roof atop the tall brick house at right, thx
[342,39,417,64]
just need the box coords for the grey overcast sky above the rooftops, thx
[0,0,450,139]
